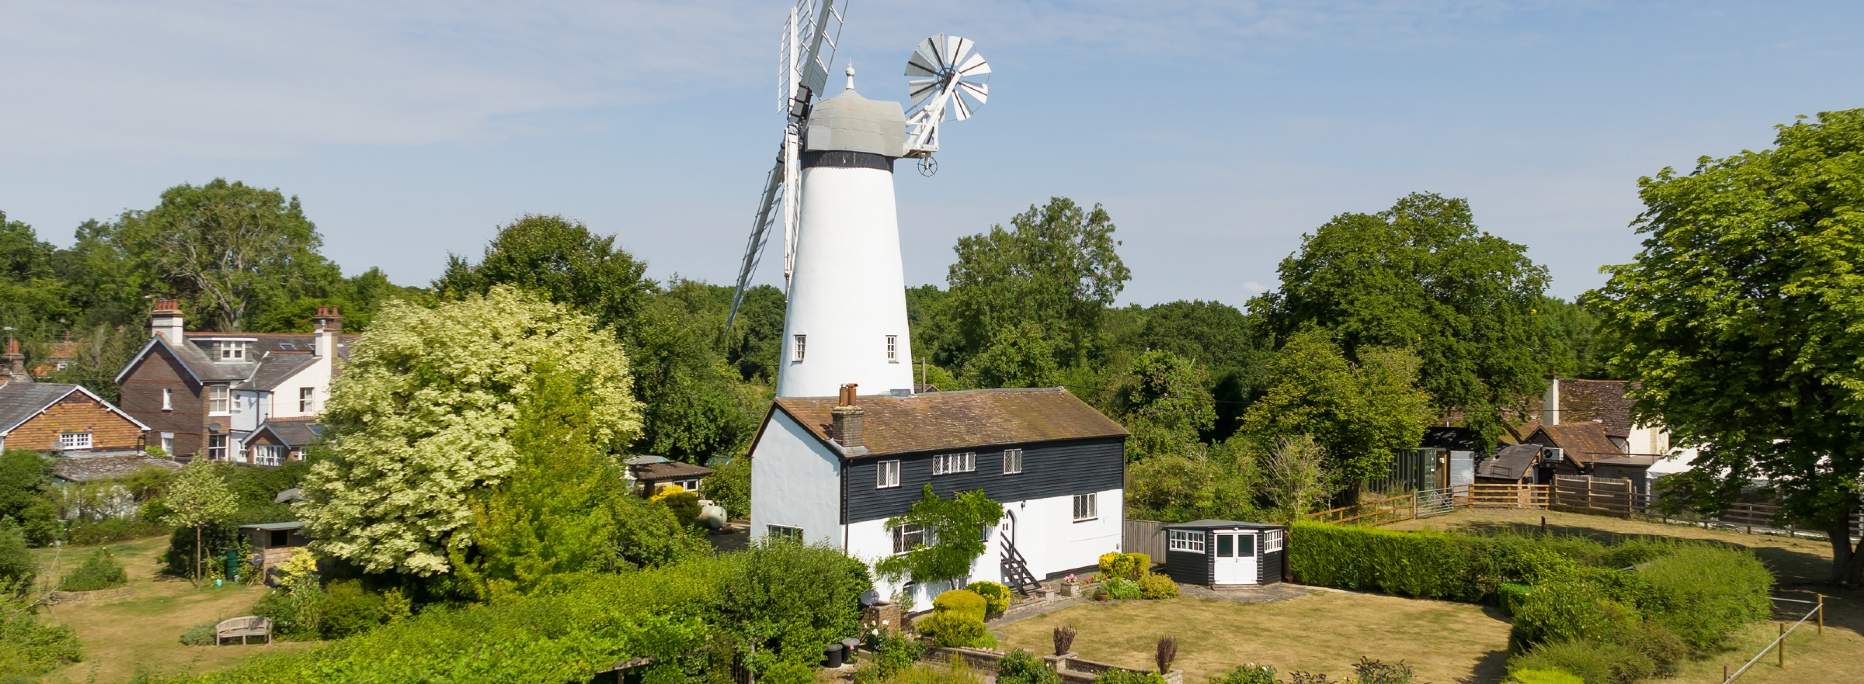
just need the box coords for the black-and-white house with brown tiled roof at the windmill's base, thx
[751,388,1128,606]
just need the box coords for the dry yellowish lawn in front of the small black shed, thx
[997,591,1508,682]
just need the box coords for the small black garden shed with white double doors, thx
[1165,520,1288,587]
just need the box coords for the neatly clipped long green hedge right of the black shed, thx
[1288,522,1579,602]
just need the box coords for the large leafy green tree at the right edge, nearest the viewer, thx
[1583,110,1864,583]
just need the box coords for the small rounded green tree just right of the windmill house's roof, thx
[1113,352,1217,460]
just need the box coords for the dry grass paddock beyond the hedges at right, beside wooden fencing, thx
[1387,511,1864,684]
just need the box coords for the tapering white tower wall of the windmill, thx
[777,166,913,397]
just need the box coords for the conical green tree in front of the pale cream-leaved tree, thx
[449,362,705,600]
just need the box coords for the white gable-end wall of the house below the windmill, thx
[751,410,843,548]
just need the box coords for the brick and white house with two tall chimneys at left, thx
[117,300,354,464]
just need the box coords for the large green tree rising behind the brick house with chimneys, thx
[103,179,341,330]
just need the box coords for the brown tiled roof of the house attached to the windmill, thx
[775,388,1128,457]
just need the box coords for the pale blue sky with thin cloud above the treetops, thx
[0,0,1864,304]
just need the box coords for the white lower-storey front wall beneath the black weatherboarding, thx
[846,490,1118,611]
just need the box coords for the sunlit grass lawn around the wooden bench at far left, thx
[34,537,311,682]
